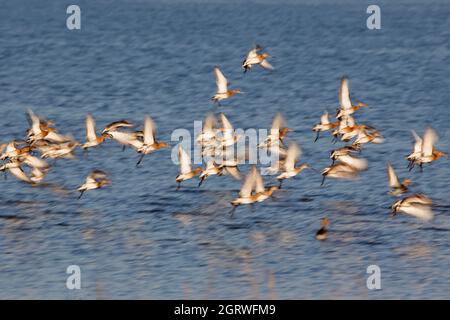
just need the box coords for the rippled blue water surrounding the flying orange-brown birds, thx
[0,0,450,299]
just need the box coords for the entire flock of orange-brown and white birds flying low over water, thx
[0,46,446,240]
